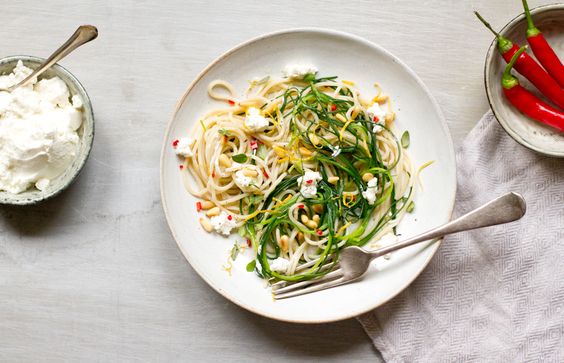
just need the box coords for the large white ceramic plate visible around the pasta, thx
[161,29,456,323]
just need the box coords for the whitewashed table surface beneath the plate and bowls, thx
[0,0,548,362]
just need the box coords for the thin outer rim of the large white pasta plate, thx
[159,27,458,324]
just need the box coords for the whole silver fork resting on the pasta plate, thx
[272,193,526,299]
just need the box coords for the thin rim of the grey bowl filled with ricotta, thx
[0,55,96,206]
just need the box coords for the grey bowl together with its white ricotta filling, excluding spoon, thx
[0,56,94,205]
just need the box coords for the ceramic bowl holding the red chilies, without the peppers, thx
[484,4,564,157]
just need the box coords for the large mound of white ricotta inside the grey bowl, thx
[0,61,83,194]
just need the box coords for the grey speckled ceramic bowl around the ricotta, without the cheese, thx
[0,56,94,205]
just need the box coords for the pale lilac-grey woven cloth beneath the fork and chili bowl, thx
[358,113,564,362]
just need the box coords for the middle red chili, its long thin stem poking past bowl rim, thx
[474,11,564,108]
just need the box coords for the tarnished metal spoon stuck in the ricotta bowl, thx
[0,25,98,92]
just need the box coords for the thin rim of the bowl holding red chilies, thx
[484,3,564,158]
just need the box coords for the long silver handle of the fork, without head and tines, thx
[369,192,526,259]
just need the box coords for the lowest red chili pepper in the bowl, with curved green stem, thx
[501,46,564,131]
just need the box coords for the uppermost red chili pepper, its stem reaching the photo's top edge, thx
[523,0,564,87]
